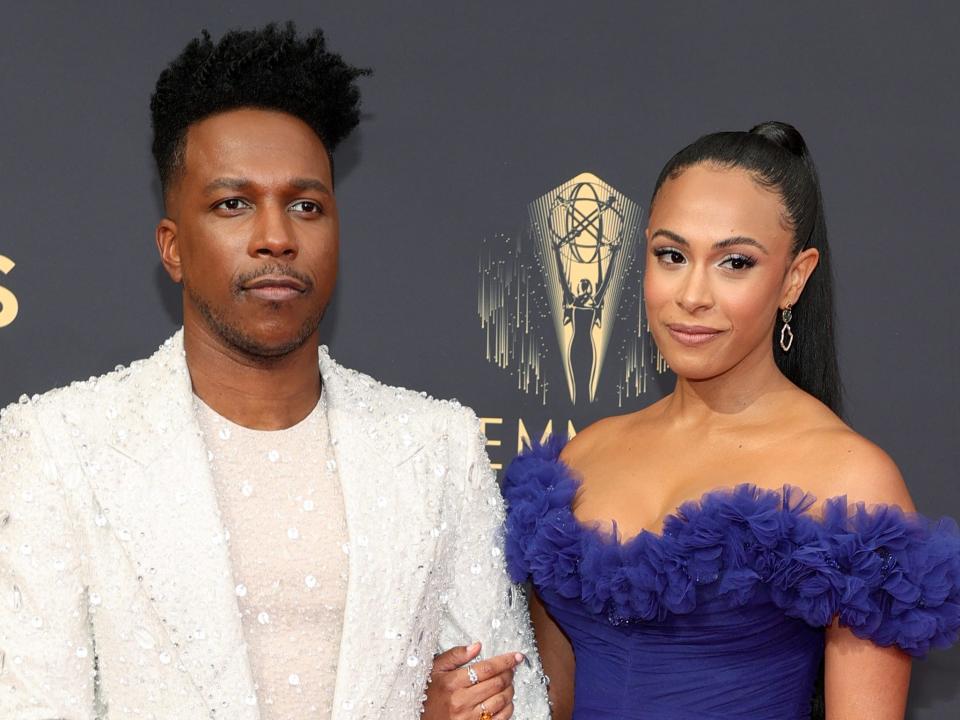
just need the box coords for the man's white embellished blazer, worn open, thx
[0,332,549,720]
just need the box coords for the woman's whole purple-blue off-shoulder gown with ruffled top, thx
[503,438,960,720]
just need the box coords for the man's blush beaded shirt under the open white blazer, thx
[196,396,348,720]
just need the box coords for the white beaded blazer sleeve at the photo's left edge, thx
[0,403,96,720]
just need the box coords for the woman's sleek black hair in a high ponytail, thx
[651,122,842,415]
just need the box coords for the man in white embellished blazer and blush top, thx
[0,25,548,720]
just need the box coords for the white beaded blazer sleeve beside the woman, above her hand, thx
[440,411,550,720]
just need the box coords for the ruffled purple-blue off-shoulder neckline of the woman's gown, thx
[503,437,960,655]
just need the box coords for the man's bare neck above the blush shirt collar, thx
[183,323,321,430]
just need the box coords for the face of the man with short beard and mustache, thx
[157,109,339,358]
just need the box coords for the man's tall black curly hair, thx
[150,22,370,192]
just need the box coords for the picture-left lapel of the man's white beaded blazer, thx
[68,333,258,720]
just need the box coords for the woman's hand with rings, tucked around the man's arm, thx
[421,642,523,720]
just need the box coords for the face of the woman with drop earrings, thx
[644,164,818,380]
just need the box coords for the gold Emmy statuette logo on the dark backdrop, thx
[477,173,666,405]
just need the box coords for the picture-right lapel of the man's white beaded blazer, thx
[320,349,440,720]
